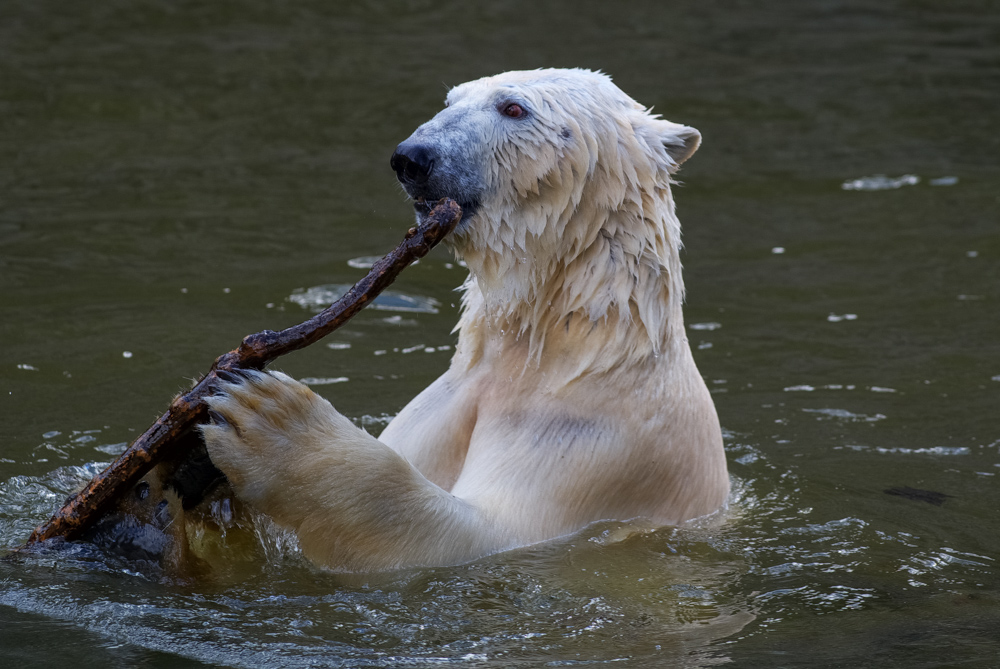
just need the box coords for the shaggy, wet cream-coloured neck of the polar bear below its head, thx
[456,180,685,375]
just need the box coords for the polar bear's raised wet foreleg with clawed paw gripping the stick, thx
[202,371,511,571]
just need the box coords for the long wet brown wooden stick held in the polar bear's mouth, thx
[27,198,462,545]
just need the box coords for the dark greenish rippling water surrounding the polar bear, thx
[0,0,1000,668]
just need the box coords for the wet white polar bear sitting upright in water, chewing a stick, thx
[203,69,729,571]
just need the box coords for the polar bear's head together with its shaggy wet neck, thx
[391,69,701,362]
